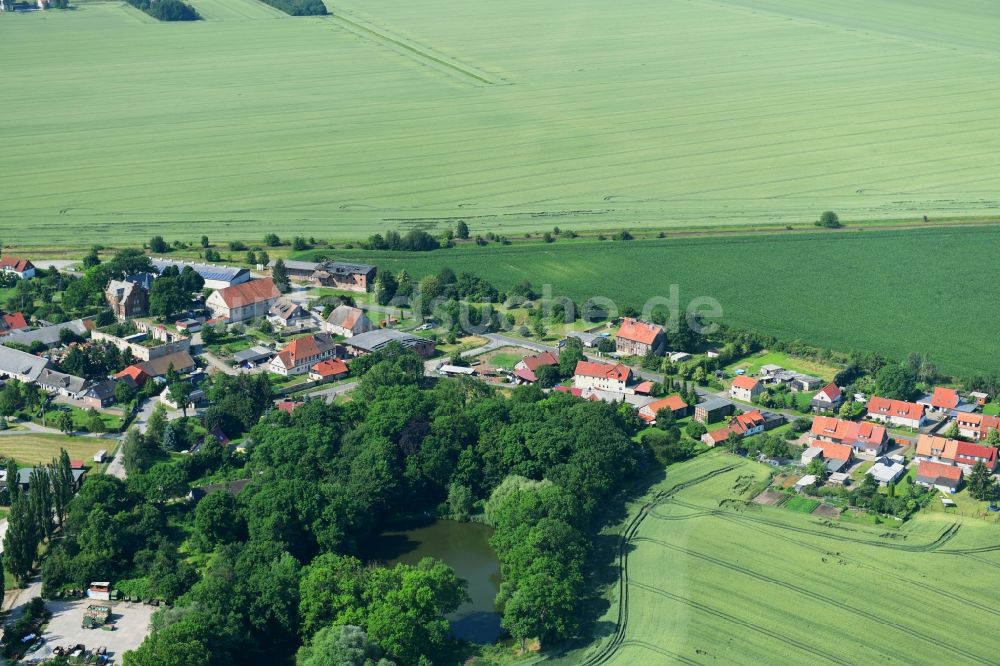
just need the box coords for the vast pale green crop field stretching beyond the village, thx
[0,0,1000,245]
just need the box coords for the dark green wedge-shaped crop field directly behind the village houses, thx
[326,227,1000,375]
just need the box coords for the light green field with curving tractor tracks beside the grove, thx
[563,453,1000,666]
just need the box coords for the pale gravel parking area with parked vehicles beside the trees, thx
[24,599,156,664]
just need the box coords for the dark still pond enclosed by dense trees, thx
[364,520,501,644]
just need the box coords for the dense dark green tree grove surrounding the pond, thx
[76,345,646,666]
